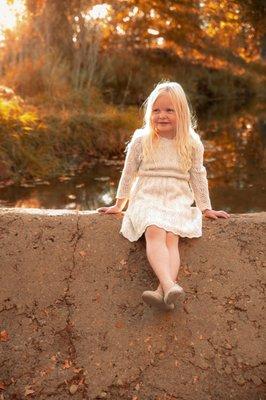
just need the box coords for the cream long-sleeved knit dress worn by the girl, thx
[116,137,211,242]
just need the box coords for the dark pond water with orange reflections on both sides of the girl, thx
[0,101,266,213]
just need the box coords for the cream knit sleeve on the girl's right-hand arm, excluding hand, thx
[189,138,212,211]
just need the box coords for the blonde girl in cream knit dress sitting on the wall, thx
[97,82,229,310]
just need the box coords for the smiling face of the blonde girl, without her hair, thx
[151,92,177,138]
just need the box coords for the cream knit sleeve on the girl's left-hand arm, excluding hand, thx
[116,137,142,199]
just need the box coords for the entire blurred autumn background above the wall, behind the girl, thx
[0,0,266,213]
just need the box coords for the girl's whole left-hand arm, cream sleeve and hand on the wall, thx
[97,137,142,214]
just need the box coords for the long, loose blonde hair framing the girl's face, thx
[133,81,200,170]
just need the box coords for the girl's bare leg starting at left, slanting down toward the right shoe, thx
[145,225,176,292]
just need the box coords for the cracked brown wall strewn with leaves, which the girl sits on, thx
[0,209,266,400]
